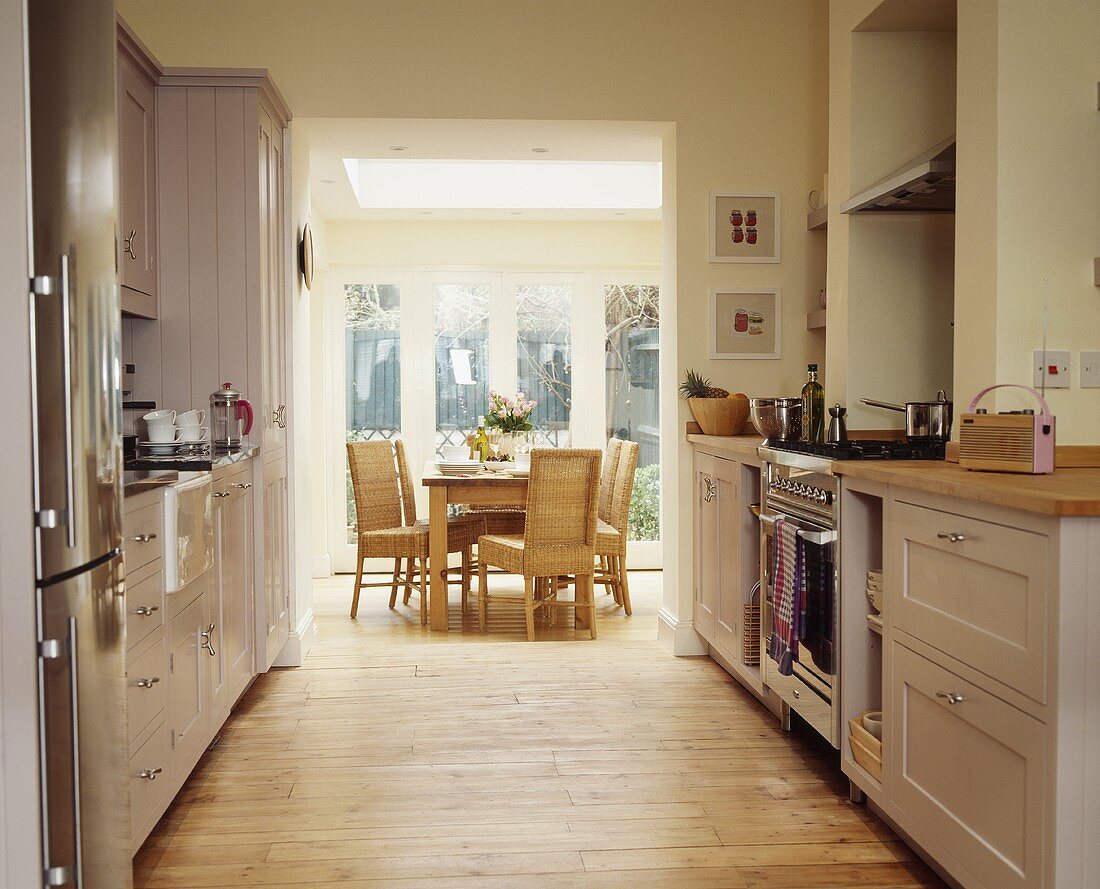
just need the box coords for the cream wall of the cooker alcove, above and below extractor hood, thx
[825,0,956,430]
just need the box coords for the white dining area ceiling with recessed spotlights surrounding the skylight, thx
[294,118,667,221]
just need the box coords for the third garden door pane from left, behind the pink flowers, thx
[516,284,573,446]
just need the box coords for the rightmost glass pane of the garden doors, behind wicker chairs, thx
[604,284,661,540]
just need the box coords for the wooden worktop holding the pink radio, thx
[833,460,1100,516]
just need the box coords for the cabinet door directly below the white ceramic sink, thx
[168,589,209,787]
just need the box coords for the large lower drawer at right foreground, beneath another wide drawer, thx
[883,641,1048,889]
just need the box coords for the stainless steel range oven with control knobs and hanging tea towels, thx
[760,448,840,747]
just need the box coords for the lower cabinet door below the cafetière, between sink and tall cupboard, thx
[215,472,255,706]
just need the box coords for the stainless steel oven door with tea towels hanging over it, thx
[760,508,839,746]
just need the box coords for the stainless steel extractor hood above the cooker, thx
[840,135,955,213]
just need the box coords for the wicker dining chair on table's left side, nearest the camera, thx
[348,439,482,624]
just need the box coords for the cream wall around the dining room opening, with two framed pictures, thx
[119,0,827,650]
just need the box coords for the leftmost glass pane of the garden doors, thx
[344,284,402,544]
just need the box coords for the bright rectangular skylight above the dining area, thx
[344,157,661,210]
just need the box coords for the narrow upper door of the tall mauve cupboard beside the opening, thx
[260,107,289,453]
